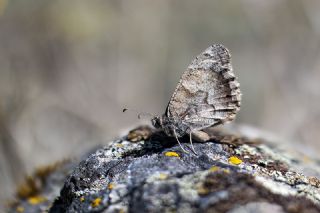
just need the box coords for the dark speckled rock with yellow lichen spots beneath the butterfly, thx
[7,127,320,213]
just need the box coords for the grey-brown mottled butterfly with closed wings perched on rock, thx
[151,44,241,153]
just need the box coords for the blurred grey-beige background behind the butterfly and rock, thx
[0,0,320,203]
